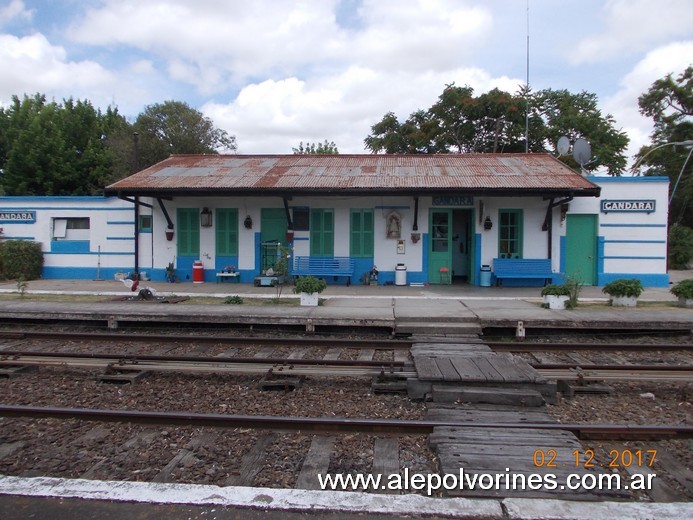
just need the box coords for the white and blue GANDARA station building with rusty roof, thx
[0,154,669,286]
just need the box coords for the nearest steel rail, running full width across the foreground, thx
[0,405,693,440]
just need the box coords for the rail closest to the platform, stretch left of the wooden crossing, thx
[0,330,412,350]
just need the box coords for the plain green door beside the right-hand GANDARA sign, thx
[565,215,597,285]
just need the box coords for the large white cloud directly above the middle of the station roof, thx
[202,66,520,154]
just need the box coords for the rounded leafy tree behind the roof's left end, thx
[133,101,236,168]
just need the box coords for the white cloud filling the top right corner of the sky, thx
[571,0,693,64]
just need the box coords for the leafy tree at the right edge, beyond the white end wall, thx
[635,67,693,227]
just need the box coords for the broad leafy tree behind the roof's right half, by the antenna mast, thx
[364,84,628,175]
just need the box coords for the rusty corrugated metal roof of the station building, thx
[106,154,599,195]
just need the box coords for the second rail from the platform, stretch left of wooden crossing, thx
[0,354,416,378]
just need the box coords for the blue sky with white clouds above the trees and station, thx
[0,0,693,164]
